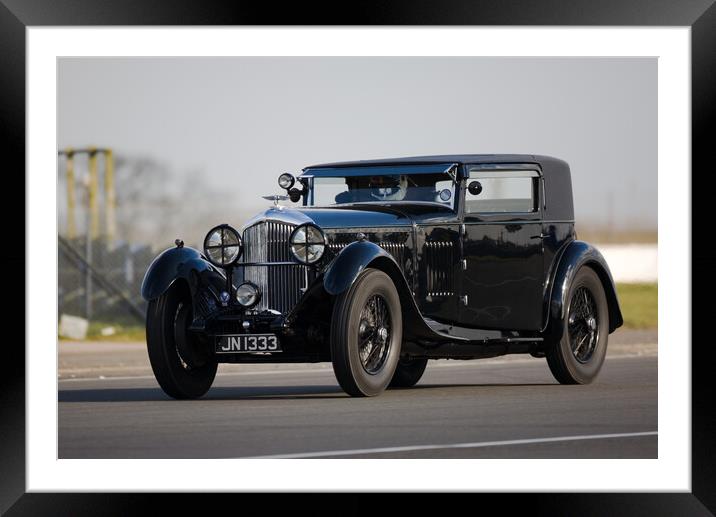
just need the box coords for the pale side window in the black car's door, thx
[465,169,539,214]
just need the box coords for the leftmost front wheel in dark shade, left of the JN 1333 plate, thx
[147,282,217,399]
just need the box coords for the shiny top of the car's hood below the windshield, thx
[243,204,420,229]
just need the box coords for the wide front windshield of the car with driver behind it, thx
[309,173,455,209]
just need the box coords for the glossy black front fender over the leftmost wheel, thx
[142,247,226,301]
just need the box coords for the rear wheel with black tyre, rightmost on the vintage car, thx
[546,266,609,384]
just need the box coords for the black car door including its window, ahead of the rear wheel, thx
[459,165,544,330]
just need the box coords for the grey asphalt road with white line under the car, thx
[58,334,657,458]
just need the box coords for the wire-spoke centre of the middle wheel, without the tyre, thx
[358,294,391,375]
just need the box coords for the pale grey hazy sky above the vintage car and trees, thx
[58,57,657,229]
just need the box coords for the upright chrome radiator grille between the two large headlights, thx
[243,221,306,314]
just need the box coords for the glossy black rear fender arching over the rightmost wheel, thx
[548,241,624,339]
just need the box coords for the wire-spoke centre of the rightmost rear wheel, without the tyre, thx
[568,286,599,363]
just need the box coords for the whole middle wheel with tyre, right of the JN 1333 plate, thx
[331,268,403,397]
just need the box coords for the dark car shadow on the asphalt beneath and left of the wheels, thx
[58,383,559,402]
